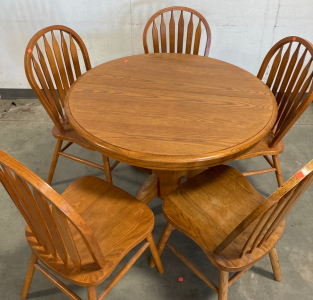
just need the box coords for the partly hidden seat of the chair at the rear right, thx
[234,132,285,160]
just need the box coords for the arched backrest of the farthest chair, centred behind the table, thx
[143,6,211,56]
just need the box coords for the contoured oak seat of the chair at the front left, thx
[26,177,154,286]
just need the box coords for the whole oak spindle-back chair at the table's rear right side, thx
[235,37,313,186]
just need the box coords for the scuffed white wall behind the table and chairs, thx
[0,0,313,88]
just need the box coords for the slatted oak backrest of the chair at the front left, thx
[0,150,105,270]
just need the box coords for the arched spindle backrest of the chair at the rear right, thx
[257,36,313,147]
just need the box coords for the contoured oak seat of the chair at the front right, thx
[163,165,285,272]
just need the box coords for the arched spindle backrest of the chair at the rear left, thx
[24,25,91,132]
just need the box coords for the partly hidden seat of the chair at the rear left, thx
[52,120,95,151]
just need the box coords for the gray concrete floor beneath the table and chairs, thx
[0,99,313,300]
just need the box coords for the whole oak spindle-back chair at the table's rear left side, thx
[24,25,119,184]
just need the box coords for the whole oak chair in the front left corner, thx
[0,150,163,300]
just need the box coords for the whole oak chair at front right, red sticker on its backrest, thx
[150,160,313,300]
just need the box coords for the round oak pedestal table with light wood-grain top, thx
[65,54,277,198]
